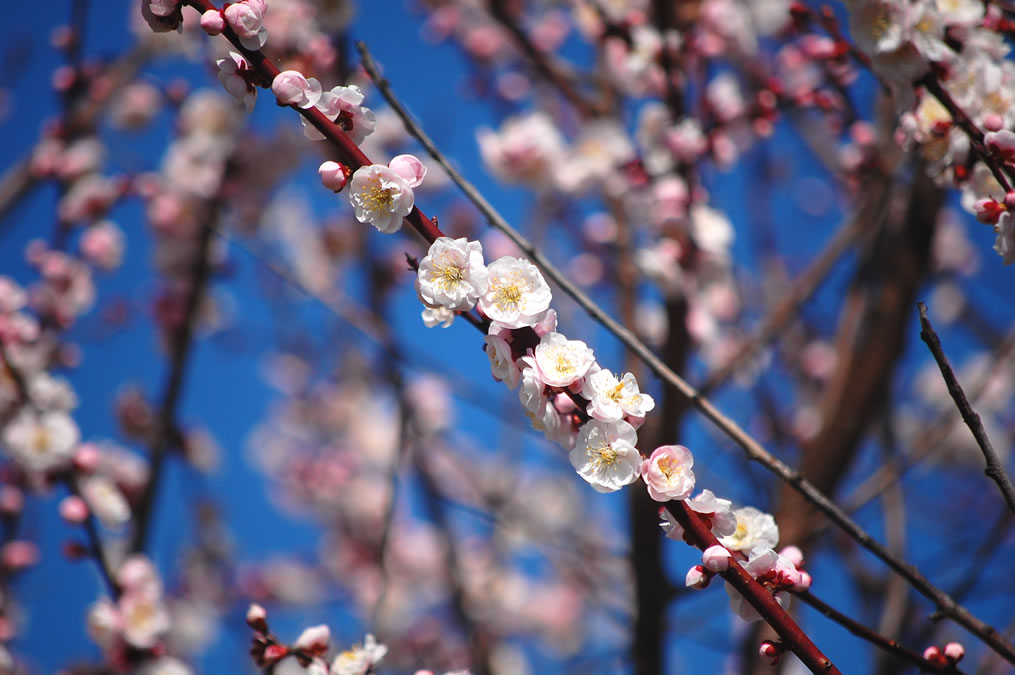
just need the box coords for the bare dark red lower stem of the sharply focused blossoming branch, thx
[666,501,839,674]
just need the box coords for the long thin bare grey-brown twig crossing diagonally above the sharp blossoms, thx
[357,43,1015,663]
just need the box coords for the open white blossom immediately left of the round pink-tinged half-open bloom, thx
[568,419,641,492]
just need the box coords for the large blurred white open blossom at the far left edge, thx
[3,407,80,473]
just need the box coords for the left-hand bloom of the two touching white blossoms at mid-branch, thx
[418,237,487,312]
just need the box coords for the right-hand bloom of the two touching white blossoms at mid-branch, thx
[479,256,551,328]
